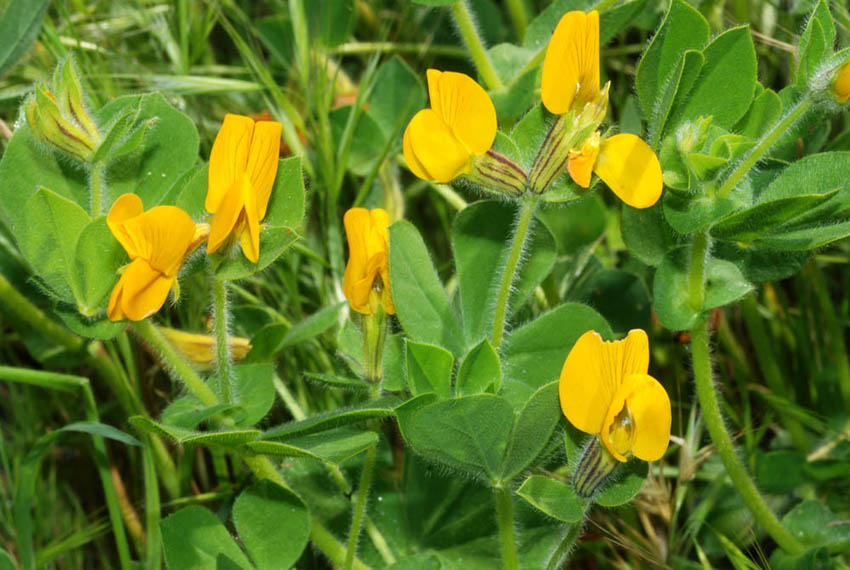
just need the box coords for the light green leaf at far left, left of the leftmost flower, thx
[15,188,91,303]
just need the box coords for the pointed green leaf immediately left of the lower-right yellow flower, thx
[502,382,561,481]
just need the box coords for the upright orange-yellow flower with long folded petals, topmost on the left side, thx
[206,114,281,263]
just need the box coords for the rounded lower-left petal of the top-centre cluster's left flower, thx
[407,109,470,182]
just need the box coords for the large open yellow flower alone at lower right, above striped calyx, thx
[559,330,671,461]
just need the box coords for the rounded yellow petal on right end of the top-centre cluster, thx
[594,133,664,208]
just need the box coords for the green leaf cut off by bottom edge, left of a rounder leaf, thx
[159,506,252,570]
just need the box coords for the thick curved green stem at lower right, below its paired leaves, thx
[691,320,806,555]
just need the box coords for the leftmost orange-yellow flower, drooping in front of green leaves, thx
[106,194,204,321]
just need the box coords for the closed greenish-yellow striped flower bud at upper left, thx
[25,59,103,162]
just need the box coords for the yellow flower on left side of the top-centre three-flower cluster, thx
[404,69,497,182]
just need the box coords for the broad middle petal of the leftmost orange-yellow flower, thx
[125,206,195,277]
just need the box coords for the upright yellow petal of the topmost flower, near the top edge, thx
[540,10,599,115]
